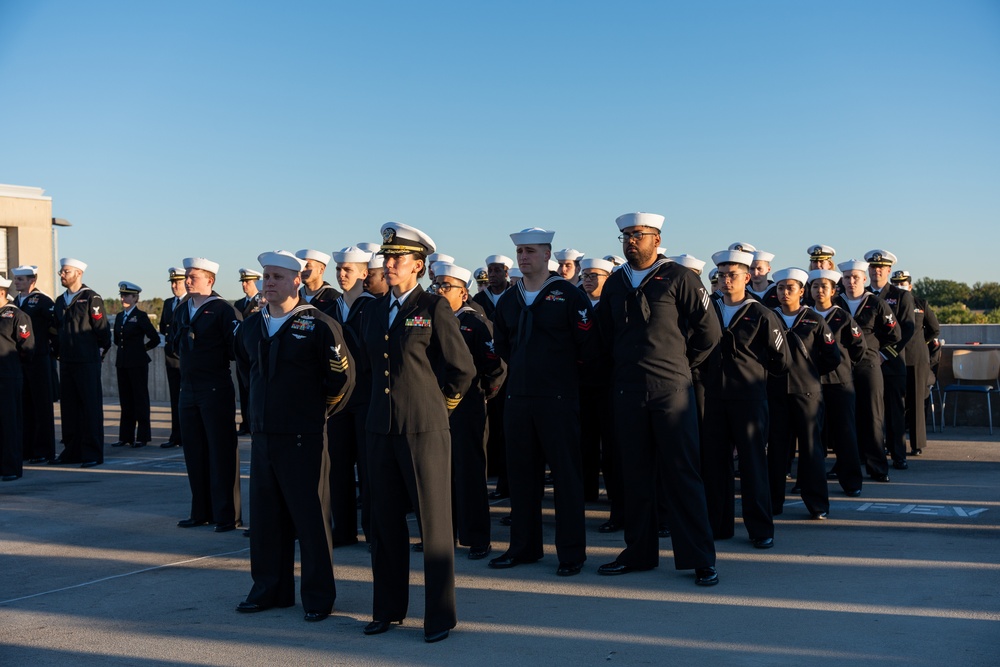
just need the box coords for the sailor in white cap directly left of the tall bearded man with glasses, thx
[490,227,600,577]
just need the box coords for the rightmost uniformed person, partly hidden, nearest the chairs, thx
[891,271,941,456]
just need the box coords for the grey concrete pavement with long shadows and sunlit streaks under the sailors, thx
[0,405,1000,667]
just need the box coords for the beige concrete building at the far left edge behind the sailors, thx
[0,184,69,296]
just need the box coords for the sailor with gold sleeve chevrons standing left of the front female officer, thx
[234,251,354,622]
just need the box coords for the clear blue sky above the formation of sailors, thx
[0,0,1000,298]
